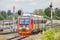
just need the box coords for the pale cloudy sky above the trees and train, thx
[0,0,60,12]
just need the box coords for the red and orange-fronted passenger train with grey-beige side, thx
[17,16,47,35]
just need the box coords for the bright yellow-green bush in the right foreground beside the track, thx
[41,28,55,40]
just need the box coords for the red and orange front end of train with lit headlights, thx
[17,17,33,35]
